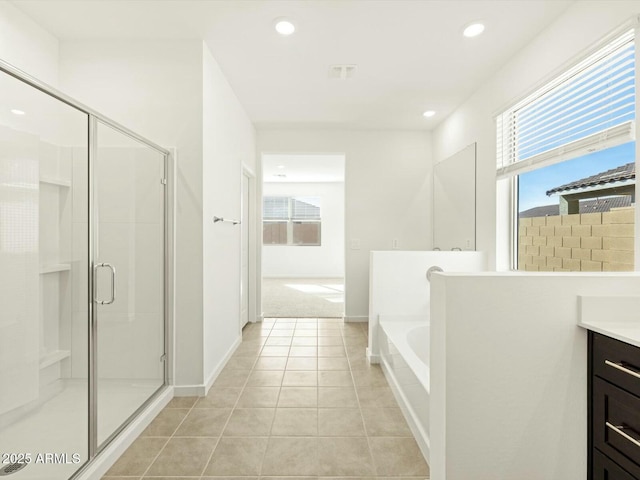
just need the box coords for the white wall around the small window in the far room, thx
[262,182,344,277]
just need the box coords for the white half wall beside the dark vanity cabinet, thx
[430,272,640,480]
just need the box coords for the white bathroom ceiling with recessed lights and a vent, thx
[13,0,572,130]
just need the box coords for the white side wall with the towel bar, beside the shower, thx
[202,45,256,384]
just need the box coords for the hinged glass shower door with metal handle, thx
[92,121,165,448]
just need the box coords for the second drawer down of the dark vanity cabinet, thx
[592,377,640,478]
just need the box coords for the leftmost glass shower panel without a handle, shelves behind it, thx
[0,68,89,480]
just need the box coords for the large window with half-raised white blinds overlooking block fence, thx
[497,30,636,271]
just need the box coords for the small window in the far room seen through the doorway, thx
[262,196,322,246]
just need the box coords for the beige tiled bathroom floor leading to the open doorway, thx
[103,318,429,480]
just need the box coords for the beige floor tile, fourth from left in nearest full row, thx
[262,437,318,476]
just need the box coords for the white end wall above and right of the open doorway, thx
[258,129,432,320]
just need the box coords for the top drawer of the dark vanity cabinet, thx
[593,334,640,396]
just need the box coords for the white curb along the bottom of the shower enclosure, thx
[73,386,173,480]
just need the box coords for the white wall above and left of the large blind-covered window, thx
[433,1,640,267]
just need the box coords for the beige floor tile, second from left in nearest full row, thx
[147,438,217,477]
